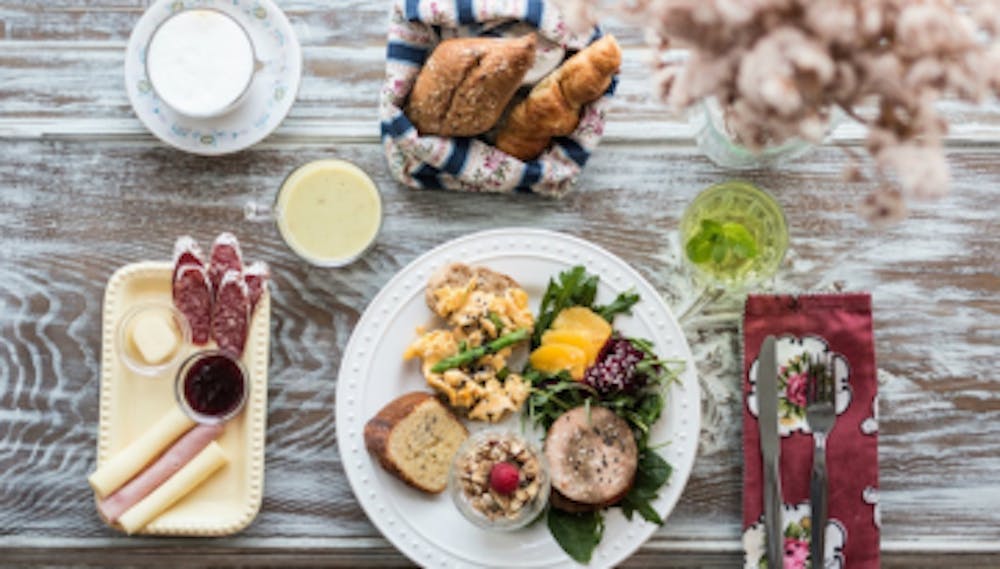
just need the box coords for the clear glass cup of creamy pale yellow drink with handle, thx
[245,159,382,267]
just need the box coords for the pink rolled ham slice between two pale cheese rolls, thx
[97,425,224,523]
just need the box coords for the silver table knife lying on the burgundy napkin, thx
[757,336,784,569]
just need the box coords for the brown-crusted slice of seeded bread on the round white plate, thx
[365,391,469,494]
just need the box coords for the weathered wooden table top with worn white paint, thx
[0,0,1000,567]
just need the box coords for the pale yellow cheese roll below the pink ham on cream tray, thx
[118,441,229,533]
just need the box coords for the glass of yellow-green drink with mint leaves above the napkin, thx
[680,180,788,290]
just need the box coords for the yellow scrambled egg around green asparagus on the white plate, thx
[403,270,535,422]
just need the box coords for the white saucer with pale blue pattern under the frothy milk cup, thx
[125,0,302,156]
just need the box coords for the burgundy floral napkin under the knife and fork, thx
[743,294,879,569]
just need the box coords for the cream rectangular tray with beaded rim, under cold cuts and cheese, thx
[97,262,271,536]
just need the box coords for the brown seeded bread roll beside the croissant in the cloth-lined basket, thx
[406,34,536,136]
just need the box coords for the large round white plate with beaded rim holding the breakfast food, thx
[337,229,701,568]
